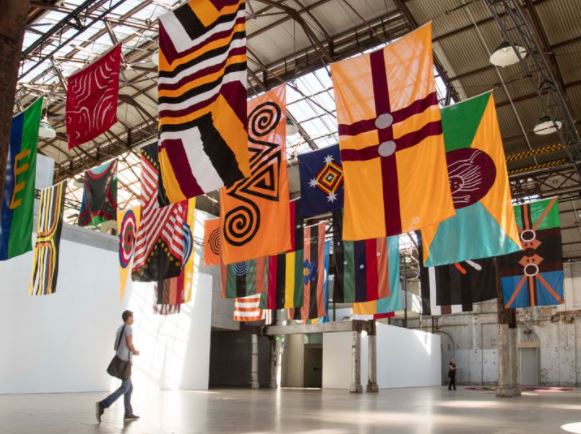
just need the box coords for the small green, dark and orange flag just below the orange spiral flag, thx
[220,258,268,298]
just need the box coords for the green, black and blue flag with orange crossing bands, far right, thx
[498,197,564,309]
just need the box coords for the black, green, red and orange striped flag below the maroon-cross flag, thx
[333,211,392,303]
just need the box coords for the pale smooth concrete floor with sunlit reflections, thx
[0,385,581,434]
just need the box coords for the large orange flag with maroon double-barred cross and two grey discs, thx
[331,23,454,240]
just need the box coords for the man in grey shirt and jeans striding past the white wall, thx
[96,310,139,423]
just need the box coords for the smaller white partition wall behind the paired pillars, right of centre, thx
[323,322,441,389]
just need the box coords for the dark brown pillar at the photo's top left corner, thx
[0,0,30,201]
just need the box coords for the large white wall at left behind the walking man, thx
[0,225,213,396]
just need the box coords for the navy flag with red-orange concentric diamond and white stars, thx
[298,145,343,217]
